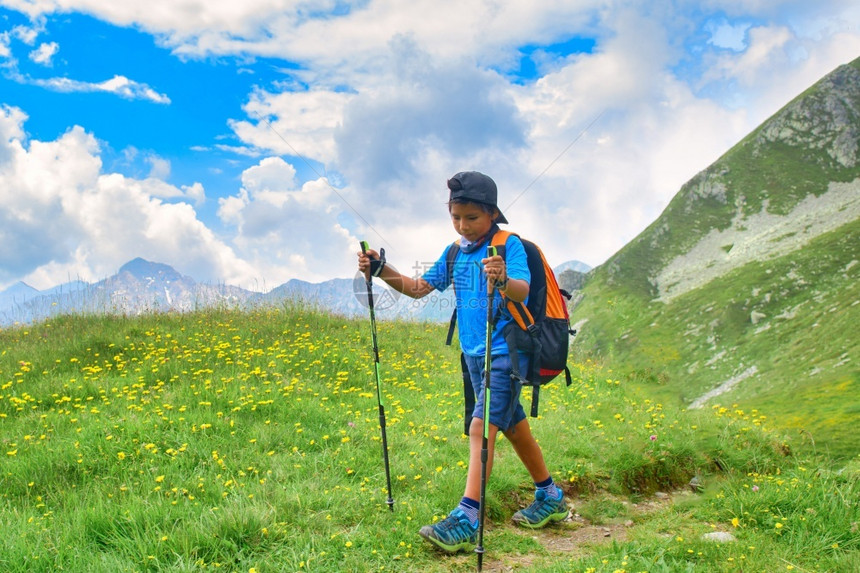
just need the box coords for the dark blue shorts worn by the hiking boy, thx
[464,354,529,432]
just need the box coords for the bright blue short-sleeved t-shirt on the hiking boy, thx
[422,235,531,356]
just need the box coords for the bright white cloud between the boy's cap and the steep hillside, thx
[464,12,746,265]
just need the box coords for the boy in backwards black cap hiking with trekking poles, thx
[358,171,567,553]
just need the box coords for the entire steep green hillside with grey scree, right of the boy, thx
[573,60,860,459]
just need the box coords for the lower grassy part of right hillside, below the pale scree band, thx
[574,217,860,457]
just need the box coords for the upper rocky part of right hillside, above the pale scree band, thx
[601,55,860,299]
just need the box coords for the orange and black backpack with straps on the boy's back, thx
[445,230,576,428]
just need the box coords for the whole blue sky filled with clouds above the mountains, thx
[0,0,860,290]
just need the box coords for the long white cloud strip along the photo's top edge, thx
[6,0,605,68]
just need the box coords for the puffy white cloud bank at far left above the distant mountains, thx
[0,107,261,288]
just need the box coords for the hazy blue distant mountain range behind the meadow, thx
[0,258,588,326]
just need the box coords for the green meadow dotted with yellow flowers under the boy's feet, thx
[0,307,860,573]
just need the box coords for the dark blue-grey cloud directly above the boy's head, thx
[335,39,527,197]
